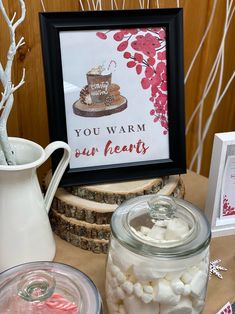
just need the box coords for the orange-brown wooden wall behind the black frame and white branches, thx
[0,0,235,176]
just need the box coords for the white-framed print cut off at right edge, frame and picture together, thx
[206,132,235,236]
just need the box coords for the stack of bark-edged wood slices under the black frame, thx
[45,173,185,253]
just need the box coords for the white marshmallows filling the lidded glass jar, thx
[106,218,209,314]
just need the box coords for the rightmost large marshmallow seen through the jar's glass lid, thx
[165,218,189,240]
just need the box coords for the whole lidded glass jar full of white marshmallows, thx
[105,195,211,314]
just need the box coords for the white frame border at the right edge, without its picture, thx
[205,132,235,237]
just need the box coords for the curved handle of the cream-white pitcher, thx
[44,141,71,213]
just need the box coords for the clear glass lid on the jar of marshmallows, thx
[111,195,211,258]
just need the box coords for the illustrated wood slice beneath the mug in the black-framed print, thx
[73,96,127,117]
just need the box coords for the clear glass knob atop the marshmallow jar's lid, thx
[148,195,176,221]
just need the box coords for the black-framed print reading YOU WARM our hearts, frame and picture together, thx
[40,9,186,186]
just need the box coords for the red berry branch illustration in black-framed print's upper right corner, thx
[96,27,168,134]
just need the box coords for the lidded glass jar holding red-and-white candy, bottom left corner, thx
[0,262,102,314]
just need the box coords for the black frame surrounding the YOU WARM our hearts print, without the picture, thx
[39,8,186,186]
